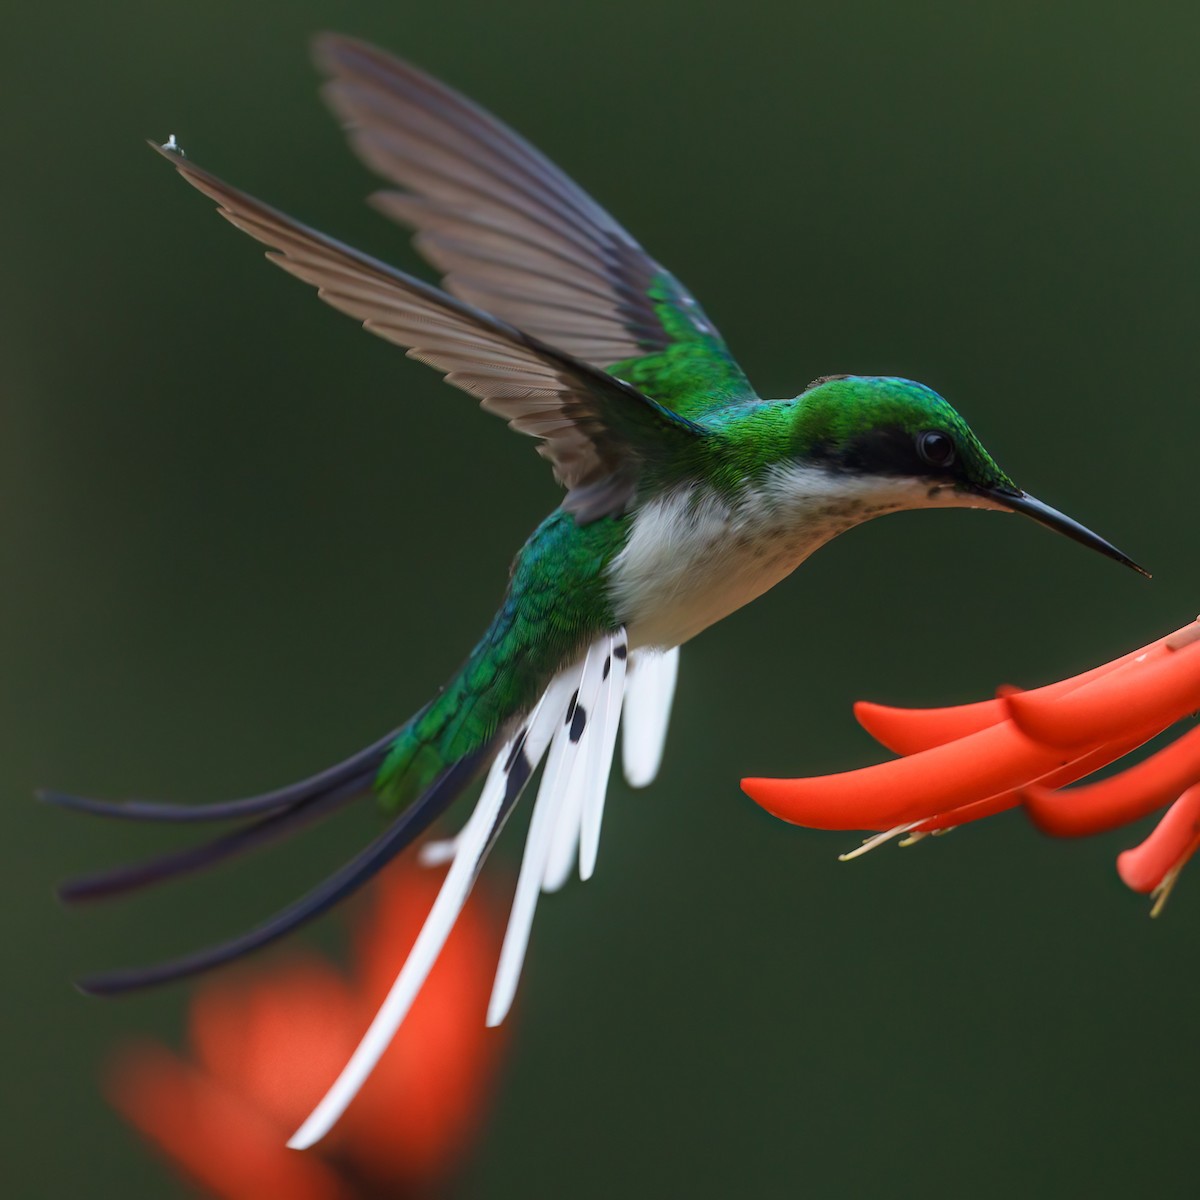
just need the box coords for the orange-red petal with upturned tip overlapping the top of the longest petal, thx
[1004,638,1200,746]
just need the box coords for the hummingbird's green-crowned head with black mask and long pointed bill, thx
[796,376,1148,576]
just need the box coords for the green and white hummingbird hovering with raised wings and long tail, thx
[54,35,1145,1147]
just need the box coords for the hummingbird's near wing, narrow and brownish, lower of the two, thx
[156,146,709,522]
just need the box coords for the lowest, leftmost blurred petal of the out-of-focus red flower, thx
[107,1045,354,1200]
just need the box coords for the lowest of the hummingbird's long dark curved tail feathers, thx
[76,748,490,996]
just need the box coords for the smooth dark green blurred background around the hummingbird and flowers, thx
[0,0,1200,1198]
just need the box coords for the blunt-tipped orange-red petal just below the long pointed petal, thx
[1025,726,1200,838]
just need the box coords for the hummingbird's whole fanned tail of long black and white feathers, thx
[49,629,678,1148]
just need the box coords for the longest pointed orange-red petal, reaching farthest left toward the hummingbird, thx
[742,721,1080,829]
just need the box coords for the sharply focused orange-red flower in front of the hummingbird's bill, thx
[742,620,1200,914]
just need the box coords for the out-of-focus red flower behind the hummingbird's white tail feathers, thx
[107,863,505,1200]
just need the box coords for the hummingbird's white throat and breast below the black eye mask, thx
[610,466,944,647]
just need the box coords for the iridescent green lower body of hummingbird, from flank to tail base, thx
[376,509,629,812]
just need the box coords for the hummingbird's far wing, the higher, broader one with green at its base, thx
[314,34,756,419]
